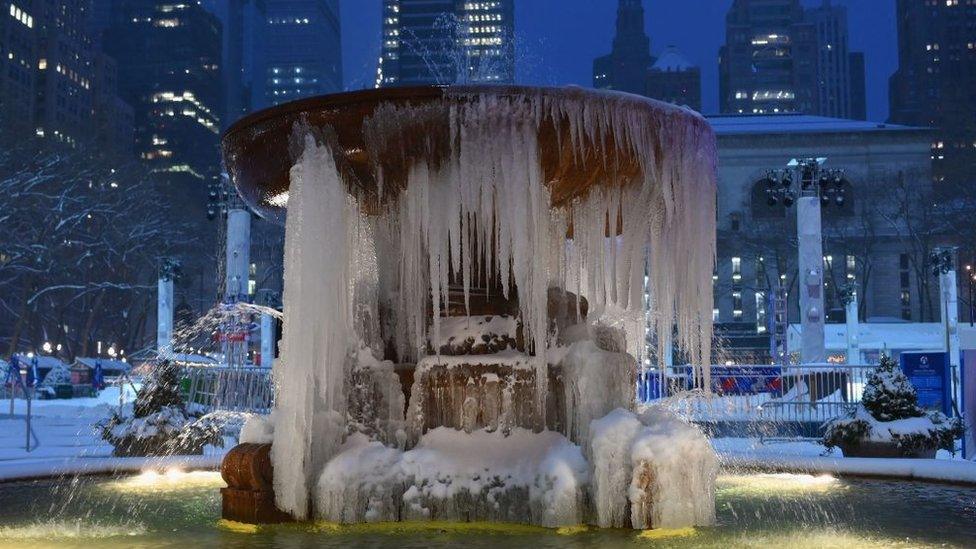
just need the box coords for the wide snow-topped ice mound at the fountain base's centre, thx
[317,428,589,527]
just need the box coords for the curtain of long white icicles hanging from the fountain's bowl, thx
[272,90,715,523]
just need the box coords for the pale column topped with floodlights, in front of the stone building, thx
[765,158,848,364]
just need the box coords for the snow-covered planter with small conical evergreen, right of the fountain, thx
[823,356,963,458]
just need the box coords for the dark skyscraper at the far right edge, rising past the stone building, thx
[890,0,976,182]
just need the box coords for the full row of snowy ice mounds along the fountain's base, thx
[315,409,718,528]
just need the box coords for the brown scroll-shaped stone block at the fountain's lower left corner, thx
[220,444,294,524]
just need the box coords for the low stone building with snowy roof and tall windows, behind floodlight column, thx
[709,114,939,363]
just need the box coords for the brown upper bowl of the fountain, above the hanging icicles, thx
[222,85,714,223]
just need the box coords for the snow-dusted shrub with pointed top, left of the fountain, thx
[98,361,223,457]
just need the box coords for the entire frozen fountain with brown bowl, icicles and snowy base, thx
[223,87,717,528]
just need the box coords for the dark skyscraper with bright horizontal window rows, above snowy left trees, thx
[103,0,223,186]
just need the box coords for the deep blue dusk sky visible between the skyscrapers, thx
[341,0,898,121]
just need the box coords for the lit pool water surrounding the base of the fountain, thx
[0,473,976,549]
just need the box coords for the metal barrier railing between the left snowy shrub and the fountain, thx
[183,366,274,414]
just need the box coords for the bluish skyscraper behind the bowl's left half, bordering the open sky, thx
[259,0,342,106]
